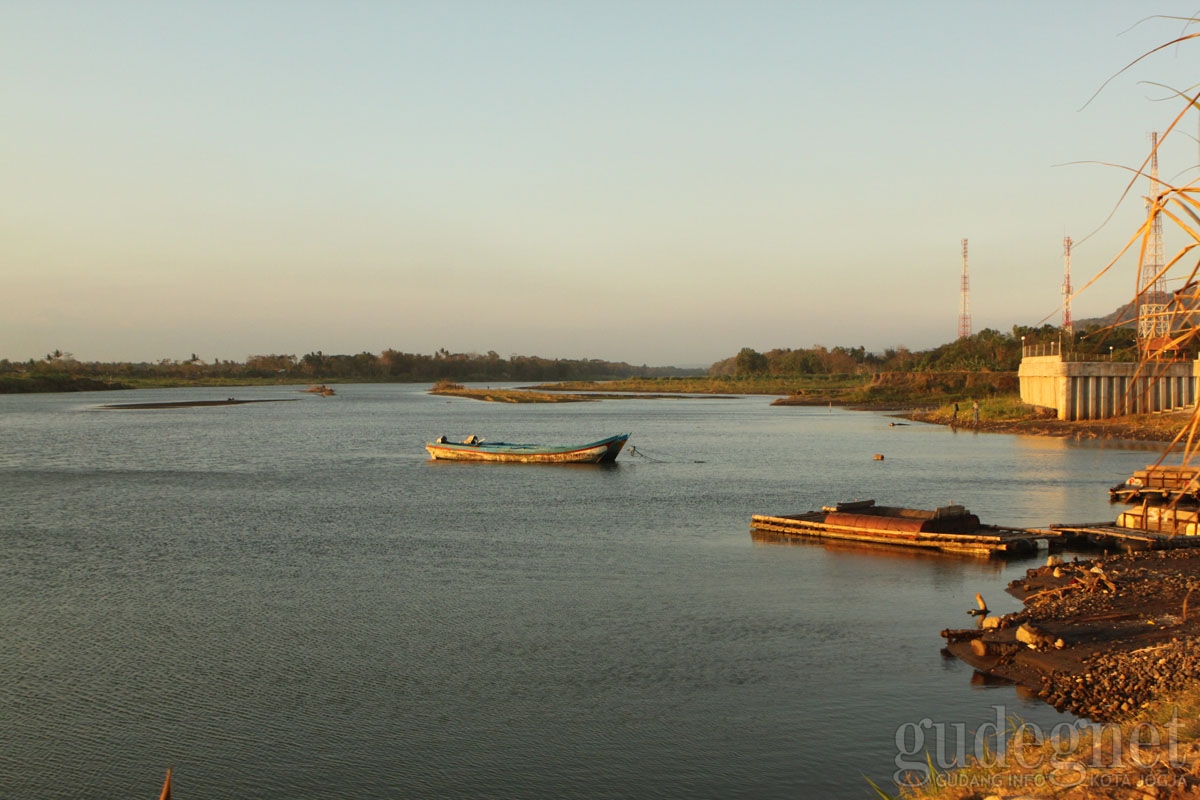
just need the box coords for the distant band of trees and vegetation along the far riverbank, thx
[0,325,1136,405]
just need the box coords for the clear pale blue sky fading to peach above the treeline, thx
[0,0,1200,366]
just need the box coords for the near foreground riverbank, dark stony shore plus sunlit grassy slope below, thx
[900,549,1200,800]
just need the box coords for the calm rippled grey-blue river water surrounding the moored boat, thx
[0,385,1158,800]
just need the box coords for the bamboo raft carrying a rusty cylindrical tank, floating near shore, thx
[750,500,1048,558]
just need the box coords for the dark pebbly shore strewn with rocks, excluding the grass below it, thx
[947,549,1200,722]
